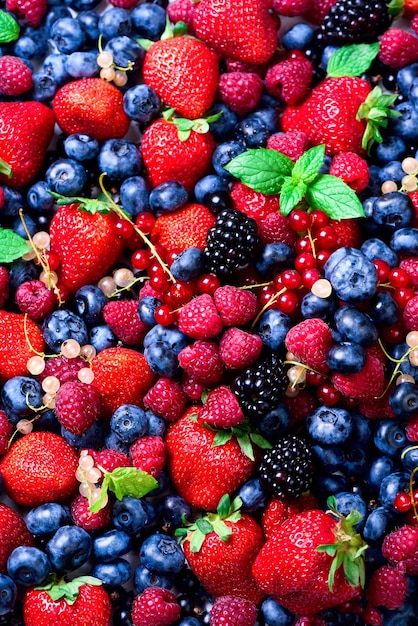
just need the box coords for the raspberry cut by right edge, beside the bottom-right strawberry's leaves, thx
[382,525,418,576]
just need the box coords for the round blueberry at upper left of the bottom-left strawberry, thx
[7,546,52,587]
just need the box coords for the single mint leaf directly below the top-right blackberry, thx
[327,42,380,78]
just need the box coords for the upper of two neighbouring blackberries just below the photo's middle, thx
[232,353,289,421]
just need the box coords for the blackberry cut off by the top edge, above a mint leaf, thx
[321,0,393,46]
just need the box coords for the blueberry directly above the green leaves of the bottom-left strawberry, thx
[45,525,92,573]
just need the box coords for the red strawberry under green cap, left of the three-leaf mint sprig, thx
[141,119,215,192]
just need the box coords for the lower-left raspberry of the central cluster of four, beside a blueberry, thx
[178,342,224,386]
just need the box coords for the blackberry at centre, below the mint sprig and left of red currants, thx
[203,209,260,278]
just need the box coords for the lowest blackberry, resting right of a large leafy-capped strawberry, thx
[258,435,312,500]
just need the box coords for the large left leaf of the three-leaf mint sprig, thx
[224,148,294,196]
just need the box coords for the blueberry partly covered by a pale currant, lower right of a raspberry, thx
[42,309,88,354]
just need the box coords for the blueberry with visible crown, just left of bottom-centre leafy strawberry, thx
[139,533,184,574]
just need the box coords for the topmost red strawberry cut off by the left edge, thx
[0,101,55,187]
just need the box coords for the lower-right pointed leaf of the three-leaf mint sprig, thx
[306,174,365,220]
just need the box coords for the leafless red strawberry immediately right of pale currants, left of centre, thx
[91,348,156,417]
